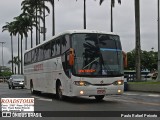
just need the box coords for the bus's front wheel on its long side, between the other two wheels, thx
[56,82,63,100]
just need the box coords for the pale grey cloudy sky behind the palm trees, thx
[0,0,158,66]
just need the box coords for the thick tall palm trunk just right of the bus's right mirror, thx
[135,0,141,81]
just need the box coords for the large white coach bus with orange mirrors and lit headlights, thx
[24,30,124,100]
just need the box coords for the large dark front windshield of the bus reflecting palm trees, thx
[71,33,123,76]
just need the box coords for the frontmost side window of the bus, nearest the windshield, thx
[61,35,70,54]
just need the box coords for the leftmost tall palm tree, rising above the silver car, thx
[2,22,15,73]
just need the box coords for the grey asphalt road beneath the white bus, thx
[0,83,160,120]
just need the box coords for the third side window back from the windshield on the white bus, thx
[43,42,51,59]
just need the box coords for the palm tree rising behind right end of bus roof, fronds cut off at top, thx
[99,0,121,32]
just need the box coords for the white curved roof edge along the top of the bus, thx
[25,30,117,53]
